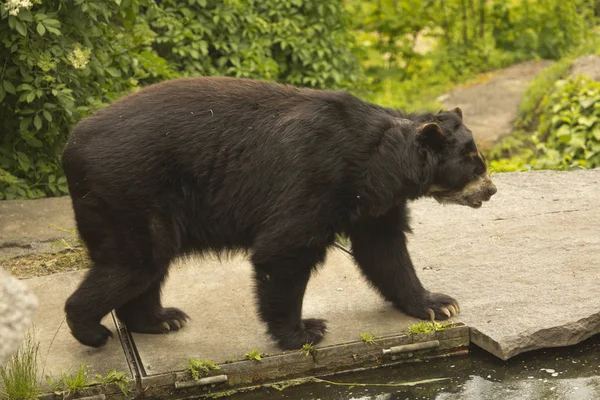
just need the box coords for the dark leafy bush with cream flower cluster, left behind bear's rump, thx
[0,0,169,199]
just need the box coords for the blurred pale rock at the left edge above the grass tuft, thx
[0,268,38,365]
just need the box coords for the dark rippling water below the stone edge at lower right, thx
[233,335,600,400]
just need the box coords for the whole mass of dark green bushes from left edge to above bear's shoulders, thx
[0,0,359,200]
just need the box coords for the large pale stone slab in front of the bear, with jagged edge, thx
[410,169,600,359]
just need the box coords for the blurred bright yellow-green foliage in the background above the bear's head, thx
[346,0,595,110]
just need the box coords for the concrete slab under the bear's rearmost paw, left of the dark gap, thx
[24,271,132,378]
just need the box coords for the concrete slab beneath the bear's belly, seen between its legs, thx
[133,250,436,375]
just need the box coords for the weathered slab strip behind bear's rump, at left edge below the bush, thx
[0,196,76,259]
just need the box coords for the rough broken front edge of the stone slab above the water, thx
[469,312,600,361]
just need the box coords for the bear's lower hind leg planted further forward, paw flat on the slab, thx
[117,275,190,333]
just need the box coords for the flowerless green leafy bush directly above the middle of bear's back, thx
[148,0,358,88]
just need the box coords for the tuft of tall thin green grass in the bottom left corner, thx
[0,333,41,400]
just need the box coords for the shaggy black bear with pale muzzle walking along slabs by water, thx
[63,77,496,349]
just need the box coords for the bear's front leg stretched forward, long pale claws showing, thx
[348,206,458,320]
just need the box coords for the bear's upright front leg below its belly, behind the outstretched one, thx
[252,249,326,350]
